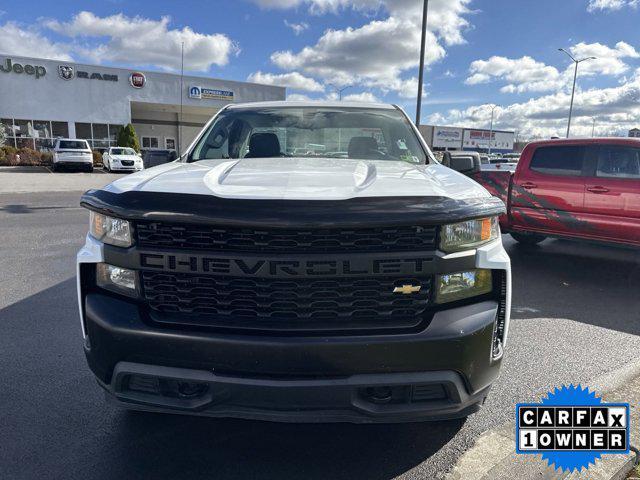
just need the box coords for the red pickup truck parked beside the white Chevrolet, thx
[472,138,640,247]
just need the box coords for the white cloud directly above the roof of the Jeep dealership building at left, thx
[43,11,239,71]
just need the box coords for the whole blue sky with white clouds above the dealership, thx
[0,0,640,139]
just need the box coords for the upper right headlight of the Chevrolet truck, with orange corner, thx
[440,217,500,253]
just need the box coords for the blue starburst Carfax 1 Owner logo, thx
[516,385,629,471]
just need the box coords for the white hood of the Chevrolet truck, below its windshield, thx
[104,158,490,200]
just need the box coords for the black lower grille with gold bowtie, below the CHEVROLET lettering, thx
[141,271,431,330]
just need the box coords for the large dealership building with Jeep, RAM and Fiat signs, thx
[0,55,285,151]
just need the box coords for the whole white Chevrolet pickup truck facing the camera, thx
[77,102,511,423]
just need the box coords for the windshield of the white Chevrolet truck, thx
[191,106,427,163]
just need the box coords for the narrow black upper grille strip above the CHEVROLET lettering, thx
[136,222,436,253]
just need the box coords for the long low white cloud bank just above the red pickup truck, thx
[427,69,640,138]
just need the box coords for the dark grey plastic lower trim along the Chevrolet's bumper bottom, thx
[103,362,488,423]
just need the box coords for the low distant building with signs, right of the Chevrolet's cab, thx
[420,125,515,153]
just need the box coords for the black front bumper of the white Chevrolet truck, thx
[78,237,511,423]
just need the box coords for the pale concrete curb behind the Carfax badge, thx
[445,359,640,480]
